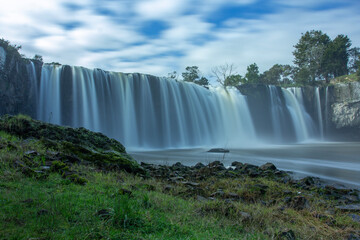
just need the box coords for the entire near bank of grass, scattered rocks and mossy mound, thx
[0,116,360,239]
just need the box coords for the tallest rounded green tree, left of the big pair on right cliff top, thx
[293,30,330,83]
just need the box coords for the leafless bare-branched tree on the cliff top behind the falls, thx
[211,63,240,87]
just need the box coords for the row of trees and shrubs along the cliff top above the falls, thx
[173,30,360,87]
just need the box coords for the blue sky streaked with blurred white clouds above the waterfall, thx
[0,0,360,78]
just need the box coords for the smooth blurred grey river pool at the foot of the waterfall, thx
[129,142,360,189]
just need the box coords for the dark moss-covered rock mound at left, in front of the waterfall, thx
[0,115,144,174]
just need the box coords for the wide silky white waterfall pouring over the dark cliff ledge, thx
[28,65,322,149]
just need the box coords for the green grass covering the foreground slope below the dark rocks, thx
[0,116,360,239]
